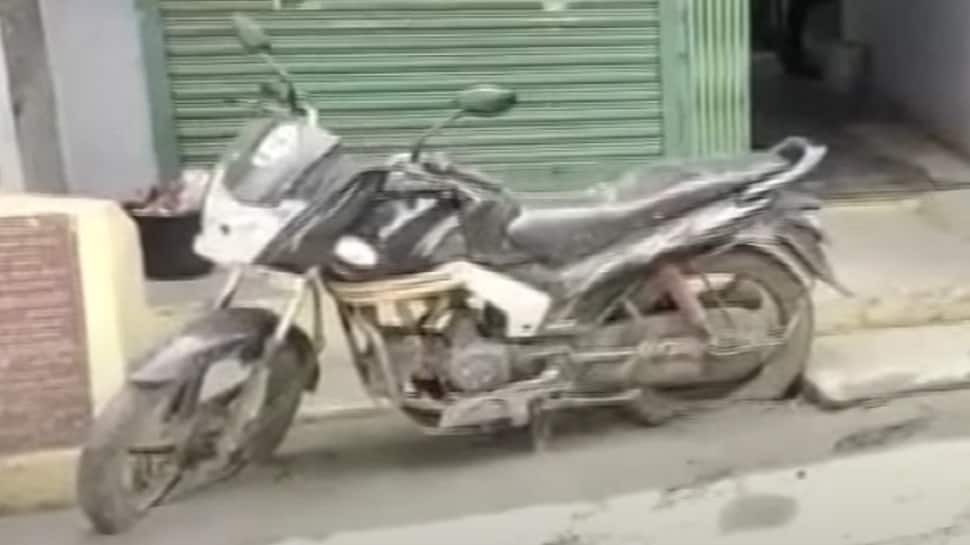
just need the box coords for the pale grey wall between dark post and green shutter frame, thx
[38,0,158,199]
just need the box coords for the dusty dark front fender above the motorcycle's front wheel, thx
[128,308,318,388]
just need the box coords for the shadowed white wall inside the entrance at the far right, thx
[843,0,970,152]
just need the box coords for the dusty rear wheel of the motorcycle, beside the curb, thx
[629,249,815,425]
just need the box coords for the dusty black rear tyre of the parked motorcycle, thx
[628,249,815,425]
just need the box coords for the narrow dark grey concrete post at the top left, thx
[0,0,66,193]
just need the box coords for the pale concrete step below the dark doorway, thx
[815,197,970,335]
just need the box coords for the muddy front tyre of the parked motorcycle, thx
[77,340,305,534]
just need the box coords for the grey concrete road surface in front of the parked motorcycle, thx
[0,392,970,545]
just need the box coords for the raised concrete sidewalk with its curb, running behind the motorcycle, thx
[149,191,970,417]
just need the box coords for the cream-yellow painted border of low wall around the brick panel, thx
[0,195,153,514]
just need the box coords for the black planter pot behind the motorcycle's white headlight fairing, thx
[125,206,212,280]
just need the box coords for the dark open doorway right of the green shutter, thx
[751,0,970,199]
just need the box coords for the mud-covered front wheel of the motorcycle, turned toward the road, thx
[77,339,305,534]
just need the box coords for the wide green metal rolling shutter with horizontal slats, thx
[159,0,664,188]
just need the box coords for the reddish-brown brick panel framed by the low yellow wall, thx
[0,215,91,455]
